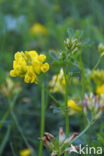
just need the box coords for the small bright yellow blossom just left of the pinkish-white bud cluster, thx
[67,99,82,115]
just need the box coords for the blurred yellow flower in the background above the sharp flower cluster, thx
[30,23,48,35]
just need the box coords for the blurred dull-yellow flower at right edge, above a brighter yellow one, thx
[92,69,104,86]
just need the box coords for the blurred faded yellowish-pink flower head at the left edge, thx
[0,77,22,97]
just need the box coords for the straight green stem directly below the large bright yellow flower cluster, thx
[38,85,45,156]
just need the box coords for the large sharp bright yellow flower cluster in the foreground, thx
[10,51,49,83]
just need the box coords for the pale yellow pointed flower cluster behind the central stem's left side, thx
[49,69,65,93]
